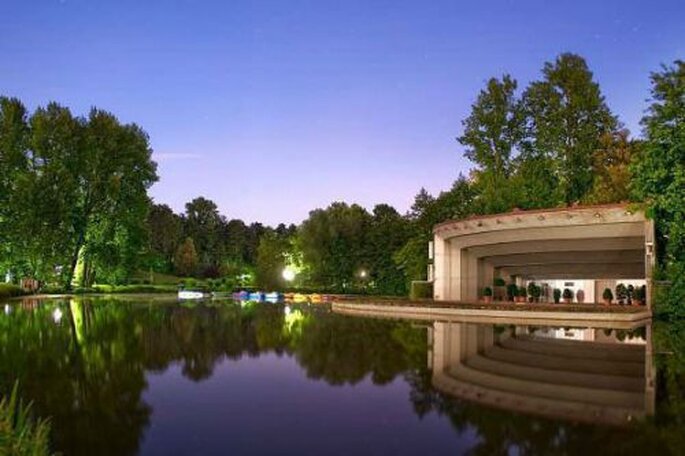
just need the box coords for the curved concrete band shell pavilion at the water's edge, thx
[431,204,655,301]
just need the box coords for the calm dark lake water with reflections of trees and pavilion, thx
[0,298,685,455]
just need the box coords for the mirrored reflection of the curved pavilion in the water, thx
[428,322,655,425]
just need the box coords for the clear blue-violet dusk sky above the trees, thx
[0,0,685,224]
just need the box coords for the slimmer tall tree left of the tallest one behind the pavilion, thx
[457,75,523,213]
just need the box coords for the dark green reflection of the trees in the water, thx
[0,298,685,455]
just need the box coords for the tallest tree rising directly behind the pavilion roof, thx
[520,53,618,204]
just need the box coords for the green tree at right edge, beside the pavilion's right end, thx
[632,60,685,316]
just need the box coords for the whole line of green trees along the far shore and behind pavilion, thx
[0,53,685,310]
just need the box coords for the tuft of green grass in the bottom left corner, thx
[0,383,50,456]
